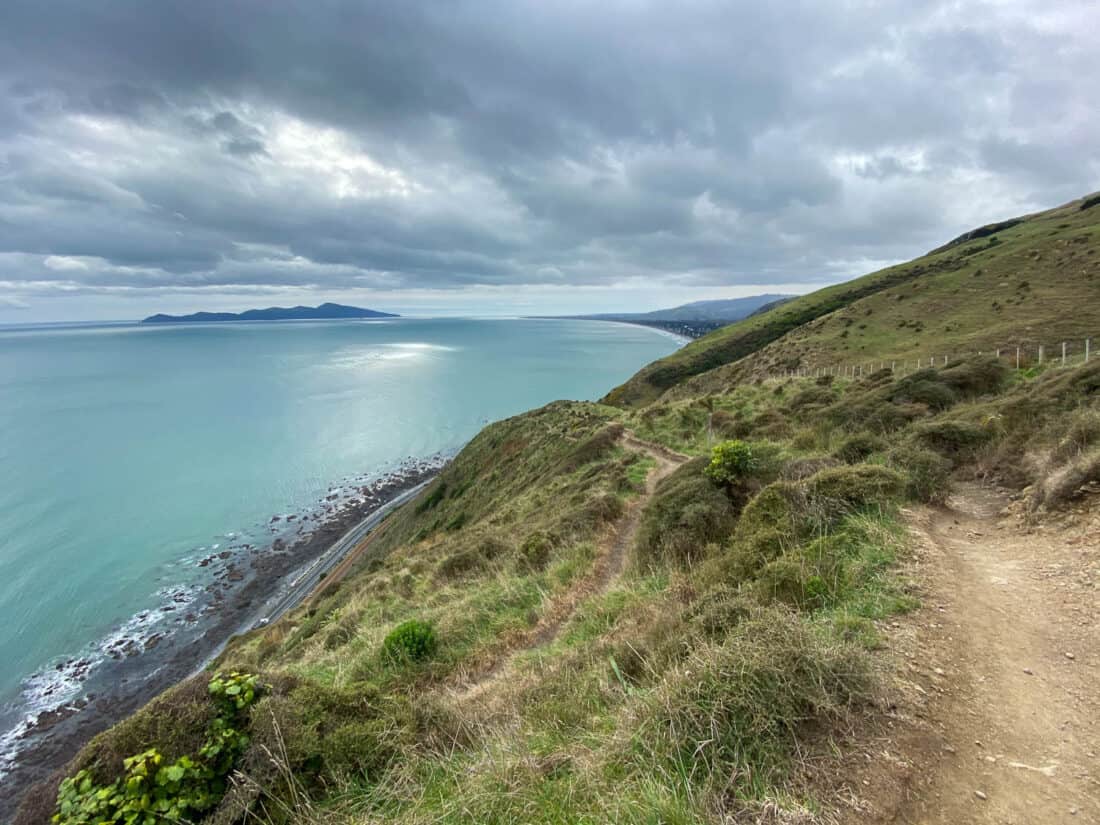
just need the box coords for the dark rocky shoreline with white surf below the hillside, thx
[0,455,447,822]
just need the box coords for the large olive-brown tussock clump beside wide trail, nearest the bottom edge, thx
[630,608,873,799]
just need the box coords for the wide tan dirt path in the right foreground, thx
[849,485,1100,825]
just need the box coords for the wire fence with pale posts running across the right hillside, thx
[770,338,1098,378]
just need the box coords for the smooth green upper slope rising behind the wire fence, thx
[604,188,1100,407]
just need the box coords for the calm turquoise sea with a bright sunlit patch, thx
[0,319,679,787]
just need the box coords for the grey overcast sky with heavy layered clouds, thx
[0,0,1100,322]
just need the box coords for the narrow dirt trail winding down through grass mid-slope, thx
[454,432,690,701]
